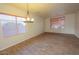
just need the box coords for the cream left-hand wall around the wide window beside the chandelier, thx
[0,5,44,50]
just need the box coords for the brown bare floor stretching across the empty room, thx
[0,33,79,55]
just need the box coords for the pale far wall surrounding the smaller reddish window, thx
[45,14,75,34]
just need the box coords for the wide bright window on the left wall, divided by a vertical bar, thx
[0,14,26,36]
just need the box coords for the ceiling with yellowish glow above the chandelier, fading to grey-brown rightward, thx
[8,3,79,18]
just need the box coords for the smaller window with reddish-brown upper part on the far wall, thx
[50,16,65,29]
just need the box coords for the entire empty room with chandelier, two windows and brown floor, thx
[0,3,79,55]
